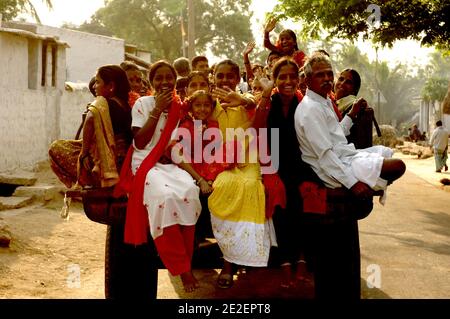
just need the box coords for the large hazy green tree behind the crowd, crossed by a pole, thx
[74,0,253,61]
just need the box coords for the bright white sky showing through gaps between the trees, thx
[19,0,433,66]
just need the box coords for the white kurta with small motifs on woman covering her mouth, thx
[131,96,201,239]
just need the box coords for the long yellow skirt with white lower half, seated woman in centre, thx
[208,164,272,267]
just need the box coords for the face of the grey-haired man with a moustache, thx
[306,61,333,98]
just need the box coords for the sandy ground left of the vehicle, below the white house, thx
[0,166,106,299]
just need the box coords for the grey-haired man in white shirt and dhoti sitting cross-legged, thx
[295,55,406,198]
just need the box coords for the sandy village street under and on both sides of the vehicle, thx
[0,153,450,299]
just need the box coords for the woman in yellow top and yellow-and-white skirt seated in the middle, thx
[208,60,274,288]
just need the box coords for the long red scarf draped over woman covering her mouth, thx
[113,95,181,245]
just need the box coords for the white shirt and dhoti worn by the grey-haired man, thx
[294,89,393,189]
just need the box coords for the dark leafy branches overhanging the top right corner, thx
[273,0,450,51]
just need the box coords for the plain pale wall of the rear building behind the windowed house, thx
[37,25,125,83]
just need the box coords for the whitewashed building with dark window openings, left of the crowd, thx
[0,19,150,173]
